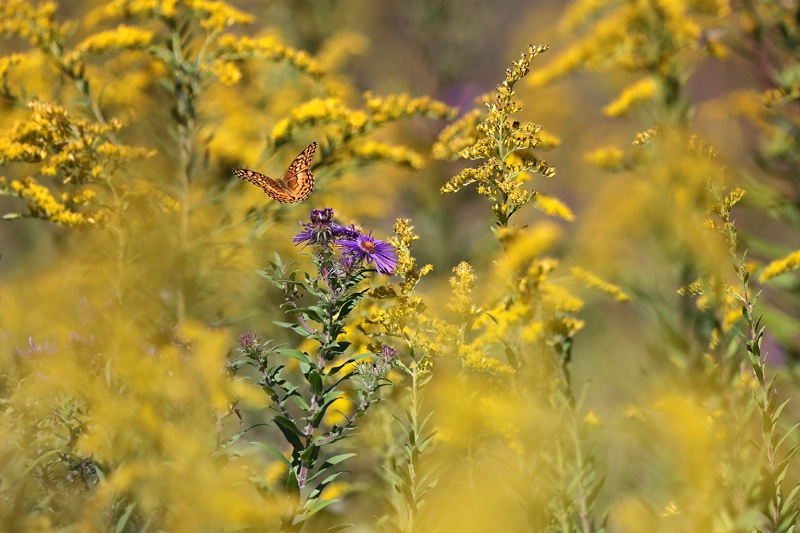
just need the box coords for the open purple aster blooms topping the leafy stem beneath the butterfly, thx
[293,207,397,275]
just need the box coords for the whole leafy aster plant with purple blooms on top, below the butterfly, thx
[238,208,398,531]
